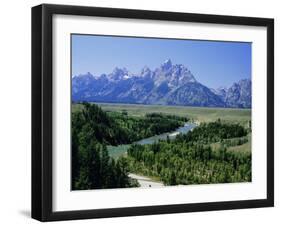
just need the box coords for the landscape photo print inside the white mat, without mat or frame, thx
[71,34,252,190]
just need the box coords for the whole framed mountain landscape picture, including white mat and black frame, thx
[32,4,274,221]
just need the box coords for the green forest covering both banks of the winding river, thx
[72,103,251,190]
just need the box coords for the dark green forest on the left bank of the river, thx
[72,103,187,190]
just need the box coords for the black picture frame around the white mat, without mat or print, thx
[32,4,274,221]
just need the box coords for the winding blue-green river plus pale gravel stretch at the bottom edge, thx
[107,123,197,187]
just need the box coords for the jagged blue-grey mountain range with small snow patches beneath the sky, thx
[72,59,252,108]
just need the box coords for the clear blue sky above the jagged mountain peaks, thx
[72,35,252,88]
